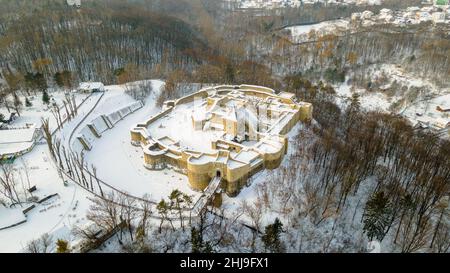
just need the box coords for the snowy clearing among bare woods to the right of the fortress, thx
[334,64,450,134]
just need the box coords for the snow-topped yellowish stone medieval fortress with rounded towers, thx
[131,85,312,202]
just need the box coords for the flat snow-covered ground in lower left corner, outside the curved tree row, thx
[0,131,89,252]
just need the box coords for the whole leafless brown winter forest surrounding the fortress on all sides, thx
[0,0,450,253]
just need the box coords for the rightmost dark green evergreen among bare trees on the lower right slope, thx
[363,191,392,241]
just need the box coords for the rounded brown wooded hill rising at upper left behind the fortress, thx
[0,1,206,82]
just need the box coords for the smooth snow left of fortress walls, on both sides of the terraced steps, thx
[81,81,199,201]
